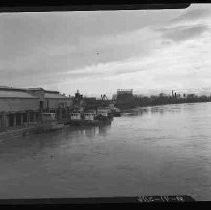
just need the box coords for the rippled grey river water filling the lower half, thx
[0,103,211,200]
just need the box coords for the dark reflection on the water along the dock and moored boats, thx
[0,125,111,160]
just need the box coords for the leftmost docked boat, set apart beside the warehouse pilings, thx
[37,113,64,132]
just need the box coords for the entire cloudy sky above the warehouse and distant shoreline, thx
[0,4,211,95]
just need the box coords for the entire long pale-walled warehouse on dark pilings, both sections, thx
[0,86,72,130]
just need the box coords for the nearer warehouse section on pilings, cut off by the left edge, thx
[0,87,39,130]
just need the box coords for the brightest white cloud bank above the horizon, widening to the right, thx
[56,23,211,94]
